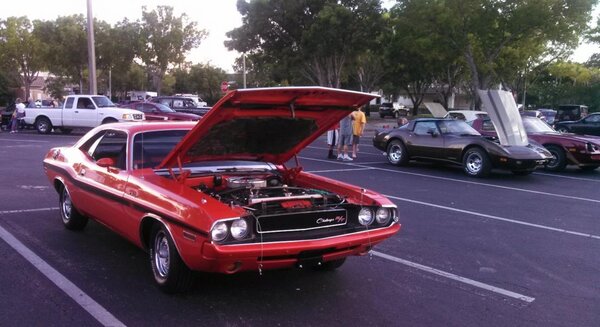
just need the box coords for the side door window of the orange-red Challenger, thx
[88,130,127,169]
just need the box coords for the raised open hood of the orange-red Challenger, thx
[158,87,378,168]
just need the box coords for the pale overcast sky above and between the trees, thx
[0,0,600,72]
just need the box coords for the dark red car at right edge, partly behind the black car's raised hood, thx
[473,117,600,171]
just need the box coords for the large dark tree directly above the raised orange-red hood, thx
[225,0,381,87]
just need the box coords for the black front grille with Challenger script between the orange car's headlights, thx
[256,209,348,234]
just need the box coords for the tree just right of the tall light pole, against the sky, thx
[141,6,207,92]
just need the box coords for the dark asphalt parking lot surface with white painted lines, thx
[0,124,600,326]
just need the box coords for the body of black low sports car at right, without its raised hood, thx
[373,118,552,177]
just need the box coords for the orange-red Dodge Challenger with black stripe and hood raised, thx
[44,87,400,292]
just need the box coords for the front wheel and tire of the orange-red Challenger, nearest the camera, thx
[148,223,193,294]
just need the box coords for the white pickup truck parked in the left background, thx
[23,94,144,134]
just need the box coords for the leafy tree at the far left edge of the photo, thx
[0,17,47,97]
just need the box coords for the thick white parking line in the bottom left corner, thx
[0,226,125,326]
